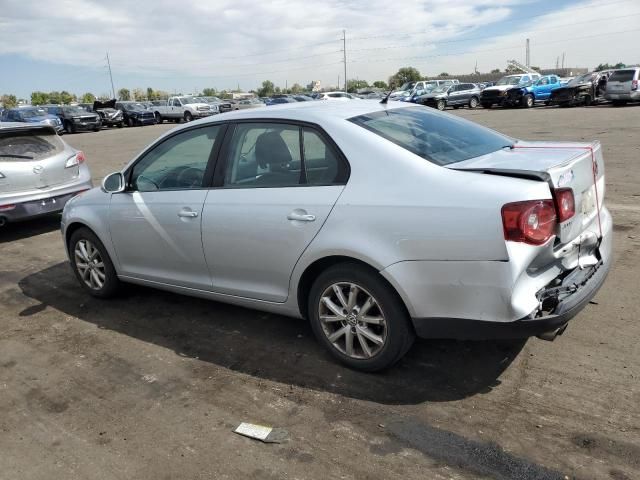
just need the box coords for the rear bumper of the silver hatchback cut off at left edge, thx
[0,175,93,223]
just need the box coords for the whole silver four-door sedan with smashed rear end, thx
[62,100,612,371]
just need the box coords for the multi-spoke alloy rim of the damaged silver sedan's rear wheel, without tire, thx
[318,282,387,359]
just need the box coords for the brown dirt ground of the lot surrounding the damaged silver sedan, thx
[0,106,640,480]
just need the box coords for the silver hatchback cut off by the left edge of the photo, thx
[0,123,93,227]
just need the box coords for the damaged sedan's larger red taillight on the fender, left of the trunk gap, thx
[502,200,557,245]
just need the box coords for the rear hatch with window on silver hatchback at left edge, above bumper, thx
[0,128,79,196]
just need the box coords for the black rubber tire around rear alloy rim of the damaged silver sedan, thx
[308,263,415,372]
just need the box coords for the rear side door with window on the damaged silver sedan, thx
[202,122,348,302]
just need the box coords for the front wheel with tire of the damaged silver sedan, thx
[69,228,120,298]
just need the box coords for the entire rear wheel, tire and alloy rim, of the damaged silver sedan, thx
[308,263,415,372]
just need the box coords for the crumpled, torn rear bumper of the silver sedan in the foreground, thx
[381,208,613,339]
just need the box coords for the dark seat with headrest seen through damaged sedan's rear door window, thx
[255,131,300,187]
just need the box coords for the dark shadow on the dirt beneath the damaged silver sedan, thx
[19,262,526,405]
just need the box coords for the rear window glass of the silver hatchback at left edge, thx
[0,132,64,162]
